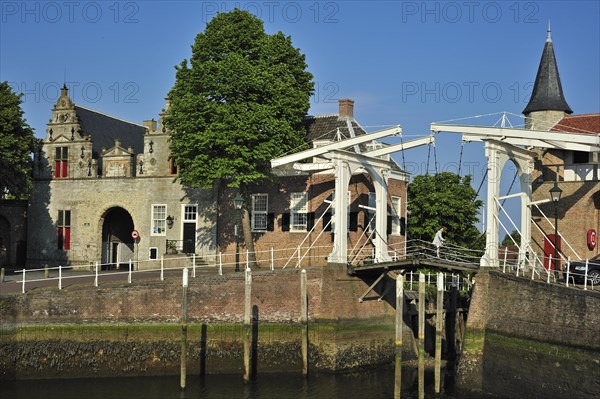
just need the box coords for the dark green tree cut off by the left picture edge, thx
[0,82,36,198]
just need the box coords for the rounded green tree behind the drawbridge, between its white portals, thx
[408,172,483,248]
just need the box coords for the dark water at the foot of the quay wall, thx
[0,367,500,399]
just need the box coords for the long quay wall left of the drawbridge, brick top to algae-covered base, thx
[0,268,413,379]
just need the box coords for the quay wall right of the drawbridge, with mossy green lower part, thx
[458,272,600,398]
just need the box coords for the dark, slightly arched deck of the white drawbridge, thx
[348,257,479,276]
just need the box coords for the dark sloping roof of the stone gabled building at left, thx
[75,105,146,154]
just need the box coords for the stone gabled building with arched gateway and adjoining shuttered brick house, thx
[27,87,407,268]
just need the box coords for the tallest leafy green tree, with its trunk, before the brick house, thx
[165,9,313,266]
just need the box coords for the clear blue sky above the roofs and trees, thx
[0,0,600,234]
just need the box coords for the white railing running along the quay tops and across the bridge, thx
[10,240,599,293]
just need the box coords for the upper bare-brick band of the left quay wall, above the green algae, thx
[3,267,393,325]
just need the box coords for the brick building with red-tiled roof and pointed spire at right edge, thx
[523,31,600,267]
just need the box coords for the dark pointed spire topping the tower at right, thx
[523,26,573,116]
